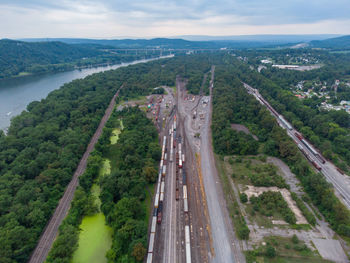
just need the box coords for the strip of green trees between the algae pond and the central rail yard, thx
[100,108,161,262]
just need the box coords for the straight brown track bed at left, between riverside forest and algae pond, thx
[29,89,120,263]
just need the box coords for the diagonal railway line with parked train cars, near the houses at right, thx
[243,83,350,209]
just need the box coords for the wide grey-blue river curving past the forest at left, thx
[0,56,169,130]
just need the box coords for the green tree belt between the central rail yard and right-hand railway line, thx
[212,58,350,239]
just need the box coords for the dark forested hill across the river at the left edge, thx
[0,39,101,79]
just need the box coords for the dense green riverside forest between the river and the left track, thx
[0,55,182,262]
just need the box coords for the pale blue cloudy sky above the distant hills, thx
[0,0,350,39]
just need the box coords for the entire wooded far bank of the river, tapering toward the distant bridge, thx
[0,39,166,79]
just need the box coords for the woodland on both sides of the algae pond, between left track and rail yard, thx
[47,108,161,262]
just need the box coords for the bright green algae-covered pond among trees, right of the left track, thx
[72,159,112,263]
